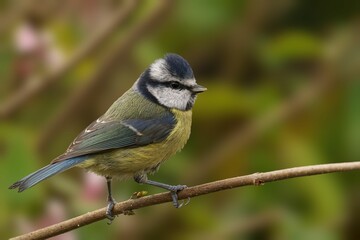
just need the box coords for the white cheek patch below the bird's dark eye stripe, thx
[147,85,192,110]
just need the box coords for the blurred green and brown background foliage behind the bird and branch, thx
[0,0,360,240]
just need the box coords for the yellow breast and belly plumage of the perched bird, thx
[81,109,192,178]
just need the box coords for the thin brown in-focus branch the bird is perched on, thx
[12,161,360,240]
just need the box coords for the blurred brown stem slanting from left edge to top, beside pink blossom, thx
[0,0,138,119]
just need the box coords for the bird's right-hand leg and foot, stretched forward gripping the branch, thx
[134,174,189,208]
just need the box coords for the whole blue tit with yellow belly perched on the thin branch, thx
[9,54,206,219]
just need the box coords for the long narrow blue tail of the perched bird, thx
[9,156,86,192]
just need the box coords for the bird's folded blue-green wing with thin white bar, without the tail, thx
[52,112,176,163]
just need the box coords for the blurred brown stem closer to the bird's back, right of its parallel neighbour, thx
[38,0,173,152]
